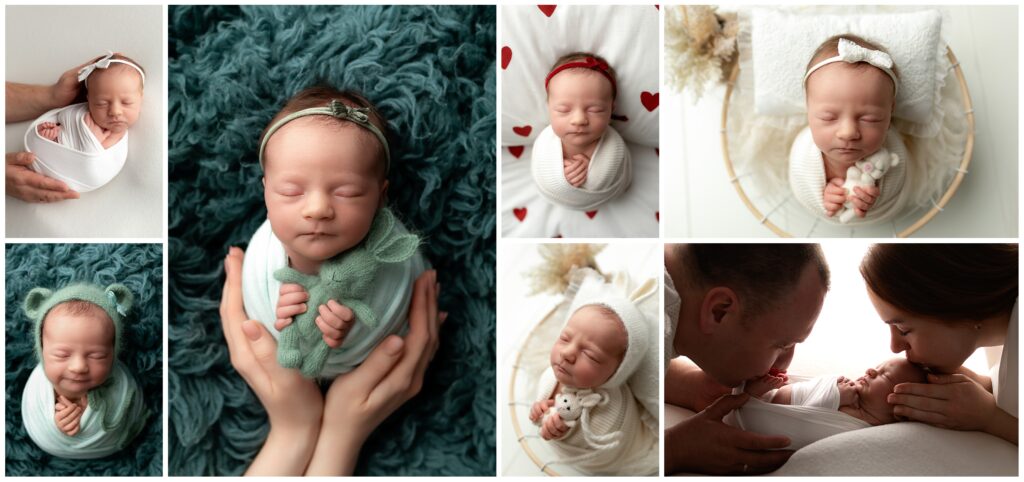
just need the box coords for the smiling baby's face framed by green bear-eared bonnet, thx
[42,306,114,398]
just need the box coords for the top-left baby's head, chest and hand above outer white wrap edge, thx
[36,53,145,152]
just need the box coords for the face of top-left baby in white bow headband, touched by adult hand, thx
[87,65,142,133]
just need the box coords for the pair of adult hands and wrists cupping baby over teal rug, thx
[220,248,445,475]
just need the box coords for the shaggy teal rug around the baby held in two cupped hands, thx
[168,5,496,476]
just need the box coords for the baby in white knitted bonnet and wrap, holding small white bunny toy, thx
[529,299,657,475]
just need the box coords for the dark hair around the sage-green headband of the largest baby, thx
[260,85,393,180]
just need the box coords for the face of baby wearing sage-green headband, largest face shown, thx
[263,117,387,271]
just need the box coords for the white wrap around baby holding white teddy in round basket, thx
[790,127,913,225]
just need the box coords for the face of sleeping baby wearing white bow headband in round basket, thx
[807,61,895,166]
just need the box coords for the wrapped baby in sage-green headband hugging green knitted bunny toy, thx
[243,87,426,379]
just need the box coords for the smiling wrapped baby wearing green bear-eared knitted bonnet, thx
[22,283,147,458]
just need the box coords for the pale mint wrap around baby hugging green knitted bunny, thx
[242,216,428,379]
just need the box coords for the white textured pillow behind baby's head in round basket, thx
[751,8,944,124]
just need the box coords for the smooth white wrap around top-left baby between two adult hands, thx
[25,103,128,192]
